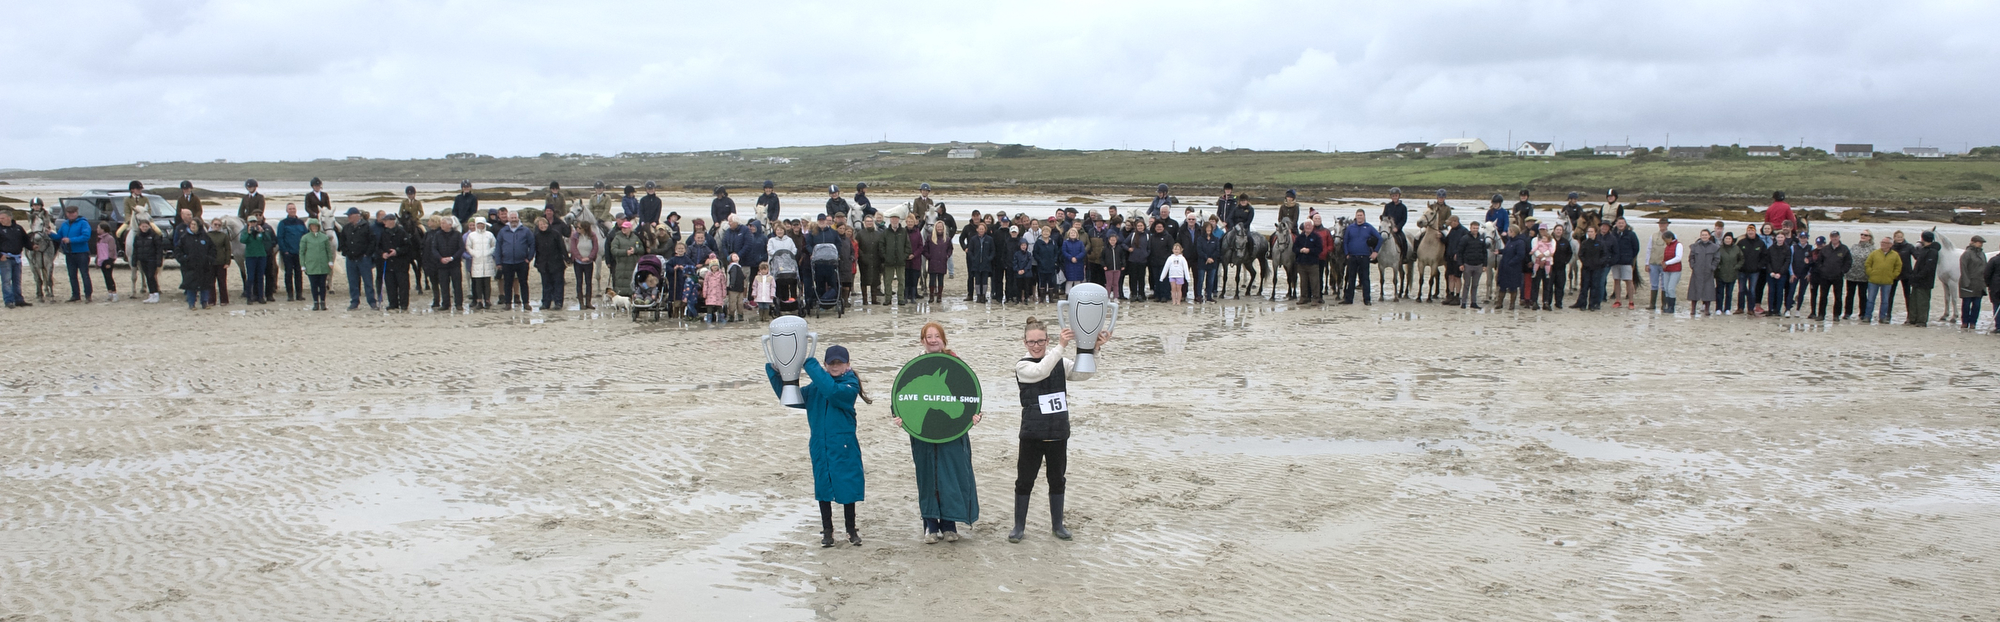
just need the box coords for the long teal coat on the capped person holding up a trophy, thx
[764,358,868,504]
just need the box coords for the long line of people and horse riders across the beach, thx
[0,180,2000,328]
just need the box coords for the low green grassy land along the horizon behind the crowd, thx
[0,142,2000,208]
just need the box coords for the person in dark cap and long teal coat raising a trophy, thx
[764,346,866,548]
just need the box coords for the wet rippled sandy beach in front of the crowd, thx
[0,182,2000,622]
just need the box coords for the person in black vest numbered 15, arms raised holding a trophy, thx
[1006,318,1112,542]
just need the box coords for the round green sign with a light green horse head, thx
[888,352,980,442]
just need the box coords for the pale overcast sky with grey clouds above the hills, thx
[0,0,2000,168]
